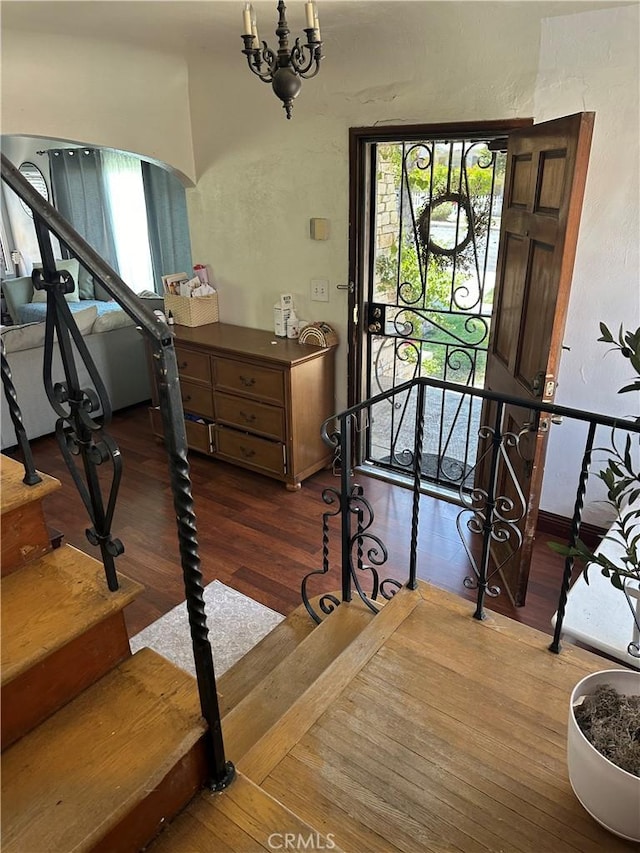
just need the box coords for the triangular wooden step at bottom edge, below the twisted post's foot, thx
[151,773,339,853]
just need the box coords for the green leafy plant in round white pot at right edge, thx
[550,323,640,842]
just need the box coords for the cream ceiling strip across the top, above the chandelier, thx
[1,0,637,55]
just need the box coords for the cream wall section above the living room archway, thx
[1,33,194,181]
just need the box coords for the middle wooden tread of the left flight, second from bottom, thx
[1,545,143,685]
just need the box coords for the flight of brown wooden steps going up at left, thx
[0,456,206,853]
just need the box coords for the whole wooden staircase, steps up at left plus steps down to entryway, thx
[0,456,352,853]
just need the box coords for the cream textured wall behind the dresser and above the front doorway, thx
[187,2,539,408]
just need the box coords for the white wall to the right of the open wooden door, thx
[535,6,640,523]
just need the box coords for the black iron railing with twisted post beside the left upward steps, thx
[2,154,235,790]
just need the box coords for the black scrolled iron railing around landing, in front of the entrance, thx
[301,377,640,656]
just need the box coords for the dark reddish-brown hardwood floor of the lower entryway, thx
[12,405,562,634]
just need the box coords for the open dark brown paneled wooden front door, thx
[479,113,595,605]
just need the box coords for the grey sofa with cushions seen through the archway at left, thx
[0,272,162,449]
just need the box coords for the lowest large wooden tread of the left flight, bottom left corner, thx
[2,649,205,853]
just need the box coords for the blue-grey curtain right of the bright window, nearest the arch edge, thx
[142,161,193,293]
